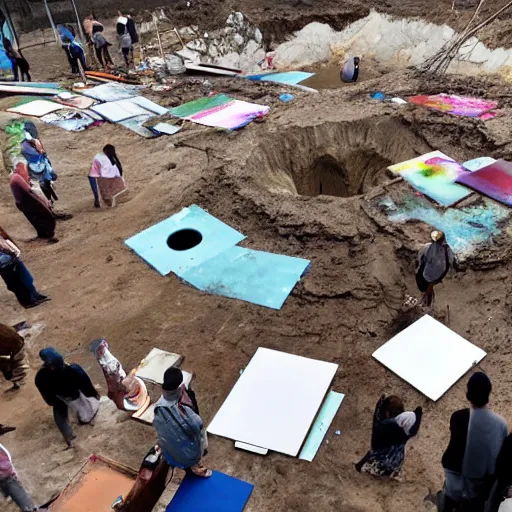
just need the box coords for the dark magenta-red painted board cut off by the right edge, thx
[457,160,512,206]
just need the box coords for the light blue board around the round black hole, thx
[125,204,245,277]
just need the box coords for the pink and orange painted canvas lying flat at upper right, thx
[408,94,498,119]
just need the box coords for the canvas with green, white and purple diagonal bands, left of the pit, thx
[171,94,270,130]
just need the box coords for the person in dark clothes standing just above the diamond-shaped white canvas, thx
[416,230,457,307]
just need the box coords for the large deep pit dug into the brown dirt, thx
[246,116,431,198]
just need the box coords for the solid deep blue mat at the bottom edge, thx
[166,471,254,512]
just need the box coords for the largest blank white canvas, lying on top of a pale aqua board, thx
[208,347,338,456]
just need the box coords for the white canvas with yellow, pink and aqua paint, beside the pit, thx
[388,151,471,206]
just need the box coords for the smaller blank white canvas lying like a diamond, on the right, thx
[373,315,486,401]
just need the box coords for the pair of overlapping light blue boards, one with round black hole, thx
[125,205,309,309]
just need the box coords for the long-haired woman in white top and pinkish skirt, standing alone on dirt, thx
[89,144,127,208]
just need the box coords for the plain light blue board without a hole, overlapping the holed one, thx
[181,247,309,309]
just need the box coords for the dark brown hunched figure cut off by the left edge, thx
[0,324,29,389]
